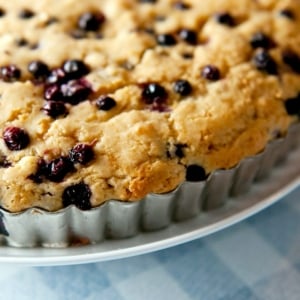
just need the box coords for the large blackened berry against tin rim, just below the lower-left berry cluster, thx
[62,182,92,210]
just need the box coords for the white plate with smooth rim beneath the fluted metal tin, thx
[0,147,300,266]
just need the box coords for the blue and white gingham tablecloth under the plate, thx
[0,188,300,300]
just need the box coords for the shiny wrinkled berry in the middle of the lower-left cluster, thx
[45,156,74,182]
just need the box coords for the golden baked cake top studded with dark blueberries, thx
[0,0,300,212]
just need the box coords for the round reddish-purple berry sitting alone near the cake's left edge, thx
[3,126,30,150]
